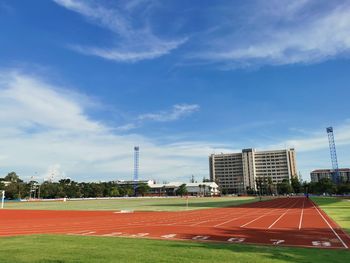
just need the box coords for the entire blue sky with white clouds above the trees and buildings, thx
[0,0,350,182]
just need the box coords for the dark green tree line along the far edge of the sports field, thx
[0,172,350,199]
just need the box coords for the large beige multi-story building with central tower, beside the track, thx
[209,149,297,193]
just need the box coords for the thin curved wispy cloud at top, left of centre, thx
[53,0,187,62]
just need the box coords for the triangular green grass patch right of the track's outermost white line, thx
[312,197,350,234]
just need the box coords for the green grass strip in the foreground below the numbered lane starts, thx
[0,235,350,263]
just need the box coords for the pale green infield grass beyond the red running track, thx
[5,197,258,211]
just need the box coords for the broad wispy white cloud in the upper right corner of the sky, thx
[191,0,350,67]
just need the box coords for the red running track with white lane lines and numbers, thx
[0,197,350,249]
